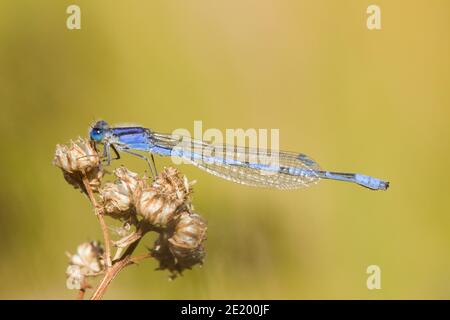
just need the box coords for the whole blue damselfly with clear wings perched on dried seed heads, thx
[90,121,389,190]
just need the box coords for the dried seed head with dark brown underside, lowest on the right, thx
[152,212,207,278]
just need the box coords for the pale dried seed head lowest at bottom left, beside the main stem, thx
[66,241,105,290]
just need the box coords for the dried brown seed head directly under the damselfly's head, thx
[53,138,103,193]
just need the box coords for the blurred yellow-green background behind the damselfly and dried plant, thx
[0,0,450,299]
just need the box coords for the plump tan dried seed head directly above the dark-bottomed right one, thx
[135,168,191,227]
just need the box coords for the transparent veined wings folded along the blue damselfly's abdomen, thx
[151,133,320,189]
